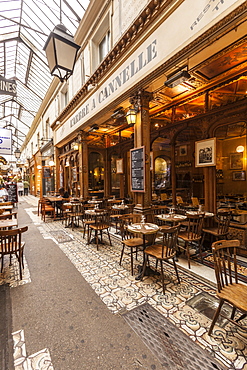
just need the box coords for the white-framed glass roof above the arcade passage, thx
[0,0,90,158]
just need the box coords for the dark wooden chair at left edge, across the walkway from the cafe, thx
[0,226,28,280]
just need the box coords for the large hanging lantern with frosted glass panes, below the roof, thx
[44,0,80,82]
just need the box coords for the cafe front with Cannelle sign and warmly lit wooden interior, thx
[53,1,247,240]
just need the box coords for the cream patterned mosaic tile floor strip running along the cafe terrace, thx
[19,199,247,370]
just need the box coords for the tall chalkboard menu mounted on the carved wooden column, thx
[130,146,145,192]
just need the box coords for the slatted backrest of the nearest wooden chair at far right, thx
[212,239,240,292]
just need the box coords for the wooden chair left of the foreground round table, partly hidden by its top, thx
[119,214,143,276]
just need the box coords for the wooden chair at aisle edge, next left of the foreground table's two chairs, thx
[89,209,112,250]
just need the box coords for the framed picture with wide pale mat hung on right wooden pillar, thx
[195,137,216,167]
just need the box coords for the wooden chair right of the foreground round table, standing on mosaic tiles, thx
[142,225,180,294]
